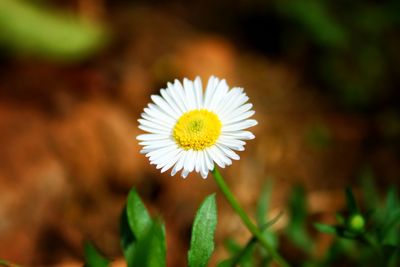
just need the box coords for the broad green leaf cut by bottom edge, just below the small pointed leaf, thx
[128,221,166,267]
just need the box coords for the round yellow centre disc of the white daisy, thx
[173,109,222,150]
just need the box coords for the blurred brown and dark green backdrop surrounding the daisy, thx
[0,0,400,266]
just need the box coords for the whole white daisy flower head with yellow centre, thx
[137,76,257,179]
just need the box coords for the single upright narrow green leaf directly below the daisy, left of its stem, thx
[188,194,217,267]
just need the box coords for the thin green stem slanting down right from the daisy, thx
[212,167,289,267]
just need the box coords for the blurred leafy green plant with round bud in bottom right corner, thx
[315,185,400,267]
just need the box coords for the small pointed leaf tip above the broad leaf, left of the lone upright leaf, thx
[126,188,151,239]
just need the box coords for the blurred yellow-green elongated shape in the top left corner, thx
[0,0,106,61]
